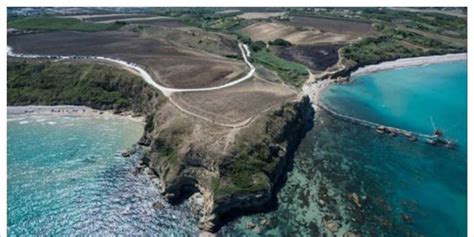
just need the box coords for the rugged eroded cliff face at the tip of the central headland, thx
[142,97,313,232]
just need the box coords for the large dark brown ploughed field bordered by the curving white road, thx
[8,31,246,88]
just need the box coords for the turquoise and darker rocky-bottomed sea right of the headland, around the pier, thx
[225,61,467,236]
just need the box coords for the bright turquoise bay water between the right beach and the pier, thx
[322,61,467,146]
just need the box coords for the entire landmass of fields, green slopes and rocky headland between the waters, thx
[8,8,467,232]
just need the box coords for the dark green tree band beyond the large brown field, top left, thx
[7,16,122,32]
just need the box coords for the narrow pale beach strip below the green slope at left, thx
[7,105,145,123]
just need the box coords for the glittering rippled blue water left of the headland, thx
[7,116,197,236]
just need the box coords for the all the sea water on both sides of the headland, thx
[7,61,467,237]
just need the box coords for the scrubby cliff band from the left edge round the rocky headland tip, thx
[7,58,314,232]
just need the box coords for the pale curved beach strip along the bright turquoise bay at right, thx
[351,53,467,77]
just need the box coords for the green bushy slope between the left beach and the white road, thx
[7,59,164,113]
